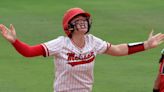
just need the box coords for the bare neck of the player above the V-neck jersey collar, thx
[71,35,85,48]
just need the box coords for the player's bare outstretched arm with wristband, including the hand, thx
[105,31,164,56]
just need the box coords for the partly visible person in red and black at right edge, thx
[153,49,164,92]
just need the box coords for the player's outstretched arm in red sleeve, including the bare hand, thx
[0,24,45,57]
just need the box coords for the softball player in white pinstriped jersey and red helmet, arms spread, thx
[0,8,164,92]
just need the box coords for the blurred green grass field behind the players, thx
[0,0,164,92]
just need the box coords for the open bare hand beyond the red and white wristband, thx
[144,30,164,49]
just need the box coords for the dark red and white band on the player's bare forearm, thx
[128,42,145,54]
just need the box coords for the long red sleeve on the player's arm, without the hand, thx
[12,40,46,57]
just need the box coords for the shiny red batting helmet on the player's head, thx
[63,8,91,38]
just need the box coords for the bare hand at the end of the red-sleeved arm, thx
[0,24,16,43]
